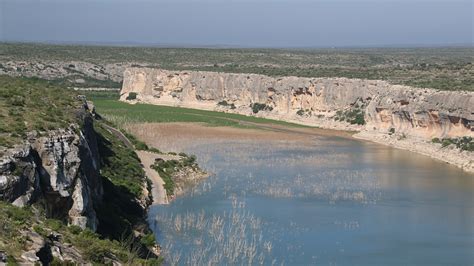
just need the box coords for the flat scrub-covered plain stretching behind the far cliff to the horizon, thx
[0,43,474,91]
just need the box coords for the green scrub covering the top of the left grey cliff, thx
[0,75,82,147]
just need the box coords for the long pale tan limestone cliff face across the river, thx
[120,68,474,139]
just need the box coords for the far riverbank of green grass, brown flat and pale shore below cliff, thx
[88,95,474,173]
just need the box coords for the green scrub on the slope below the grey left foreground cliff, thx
[0,201,160,265]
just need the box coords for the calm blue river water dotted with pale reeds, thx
[149,136,474,265]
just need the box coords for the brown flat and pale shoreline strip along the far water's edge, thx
[127,117,474,178]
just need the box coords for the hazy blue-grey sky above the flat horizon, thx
[0,0,474,47]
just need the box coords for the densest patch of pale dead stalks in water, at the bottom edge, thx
[156,196,277,265]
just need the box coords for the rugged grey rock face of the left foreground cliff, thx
[0,105,103,230]
